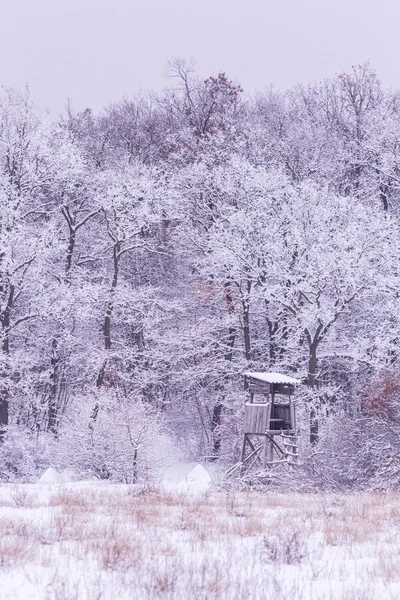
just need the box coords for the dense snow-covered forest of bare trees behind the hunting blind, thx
[0,60,400,489]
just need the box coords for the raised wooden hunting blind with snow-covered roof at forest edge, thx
[237,372,300,468]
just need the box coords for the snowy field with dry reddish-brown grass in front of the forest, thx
[0,471,400,600]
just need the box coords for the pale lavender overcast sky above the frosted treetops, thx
[0,0,400,112]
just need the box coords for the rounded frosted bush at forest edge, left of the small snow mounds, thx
[58,390,161,483]
